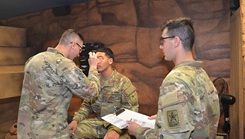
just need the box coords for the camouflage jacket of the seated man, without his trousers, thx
[73,69,138,134]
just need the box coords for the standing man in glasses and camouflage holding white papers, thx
[127,18,220,139]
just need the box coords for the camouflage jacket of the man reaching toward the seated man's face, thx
[17,48,99,139]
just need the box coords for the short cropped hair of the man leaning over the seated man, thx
[60,29,84,45]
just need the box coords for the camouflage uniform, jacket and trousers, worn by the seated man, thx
[73,70,138,138]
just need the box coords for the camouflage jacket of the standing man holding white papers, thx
[136,61,220,139]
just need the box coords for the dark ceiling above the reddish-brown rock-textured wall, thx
[0,0,240,19]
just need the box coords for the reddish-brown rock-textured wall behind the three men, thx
[0,0,230,132]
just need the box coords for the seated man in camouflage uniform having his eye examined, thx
[69,48,138,139]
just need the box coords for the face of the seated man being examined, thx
[96,52,113,72]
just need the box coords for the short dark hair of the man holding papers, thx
[161,17,195,50]
